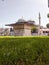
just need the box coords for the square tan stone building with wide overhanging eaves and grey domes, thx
[6,18,34,36]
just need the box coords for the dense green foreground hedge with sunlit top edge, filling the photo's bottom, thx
[0,37,49,65]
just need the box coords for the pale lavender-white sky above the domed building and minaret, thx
[0,0,49,27]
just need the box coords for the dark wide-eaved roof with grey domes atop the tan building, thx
[6,19,35,26]
